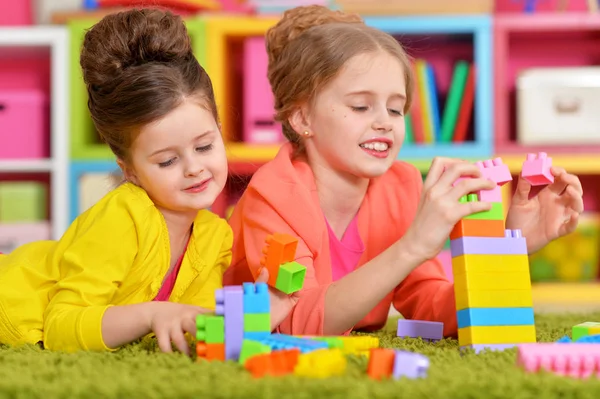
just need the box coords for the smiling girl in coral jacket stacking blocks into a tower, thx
[224,6,583,336]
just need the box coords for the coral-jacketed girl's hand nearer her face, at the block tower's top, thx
[403,158,496,264]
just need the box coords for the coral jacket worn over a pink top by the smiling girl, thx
[223,143,457,336]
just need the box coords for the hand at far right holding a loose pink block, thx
[506,167,583,254]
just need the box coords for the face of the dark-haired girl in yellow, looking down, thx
[125,99,227,217]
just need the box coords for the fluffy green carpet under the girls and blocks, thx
[0,313,600,399]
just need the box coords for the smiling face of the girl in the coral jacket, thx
[305,51,406,178]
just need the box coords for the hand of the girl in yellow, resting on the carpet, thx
[149,302,211,355]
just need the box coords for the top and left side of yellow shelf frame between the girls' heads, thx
[202,15,279,141]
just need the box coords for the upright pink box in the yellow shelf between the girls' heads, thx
[243,37,283,144]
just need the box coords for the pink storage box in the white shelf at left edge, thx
[0,89,50,159]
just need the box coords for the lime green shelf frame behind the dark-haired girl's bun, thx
[67,18,207,160]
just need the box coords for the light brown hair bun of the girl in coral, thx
[266,5,364,62]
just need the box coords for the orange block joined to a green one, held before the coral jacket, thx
[254,233,298,287]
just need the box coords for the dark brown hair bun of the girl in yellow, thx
[80,9,192,92]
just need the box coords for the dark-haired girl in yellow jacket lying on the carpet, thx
[0,10,232,353]
